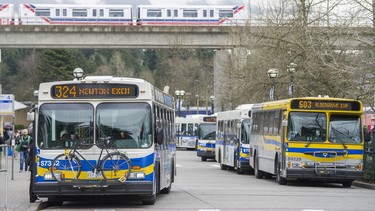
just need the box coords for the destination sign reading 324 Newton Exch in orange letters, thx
[51,84,138,99]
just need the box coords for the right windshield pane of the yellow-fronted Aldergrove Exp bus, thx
[328,115,361,144]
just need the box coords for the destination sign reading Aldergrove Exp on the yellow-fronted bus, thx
[290,100,361,111]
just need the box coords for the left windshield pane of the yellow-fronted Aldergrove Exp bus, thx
[287,112,327,142]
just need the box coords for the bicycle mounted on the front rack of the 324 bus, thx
[51,137,131,183]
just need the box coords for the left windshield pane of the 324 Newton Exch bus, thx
[37,103,94,149]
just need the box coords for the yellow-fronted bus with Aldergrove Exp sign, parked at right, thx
[250,97,364,187]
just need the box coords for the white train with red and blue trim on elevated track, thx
[0,3,249,26]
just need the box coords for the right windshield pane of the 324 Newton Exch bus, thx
[96,103,152,148]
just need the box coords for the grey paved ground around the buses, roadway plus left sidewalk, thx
[0,151,375,211]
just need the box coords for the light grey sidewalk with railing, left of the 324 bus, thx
[0,154,39,211]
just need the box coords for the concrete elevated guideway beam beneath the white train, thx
[0,25,373,49]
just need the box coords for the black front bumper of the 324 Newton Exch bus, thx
[34,181,153,197]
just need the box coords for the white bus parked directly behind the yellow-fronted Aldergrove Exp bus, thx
[215,104,253,174]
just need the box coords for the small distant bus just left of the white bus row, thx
[197,116,216,161]
